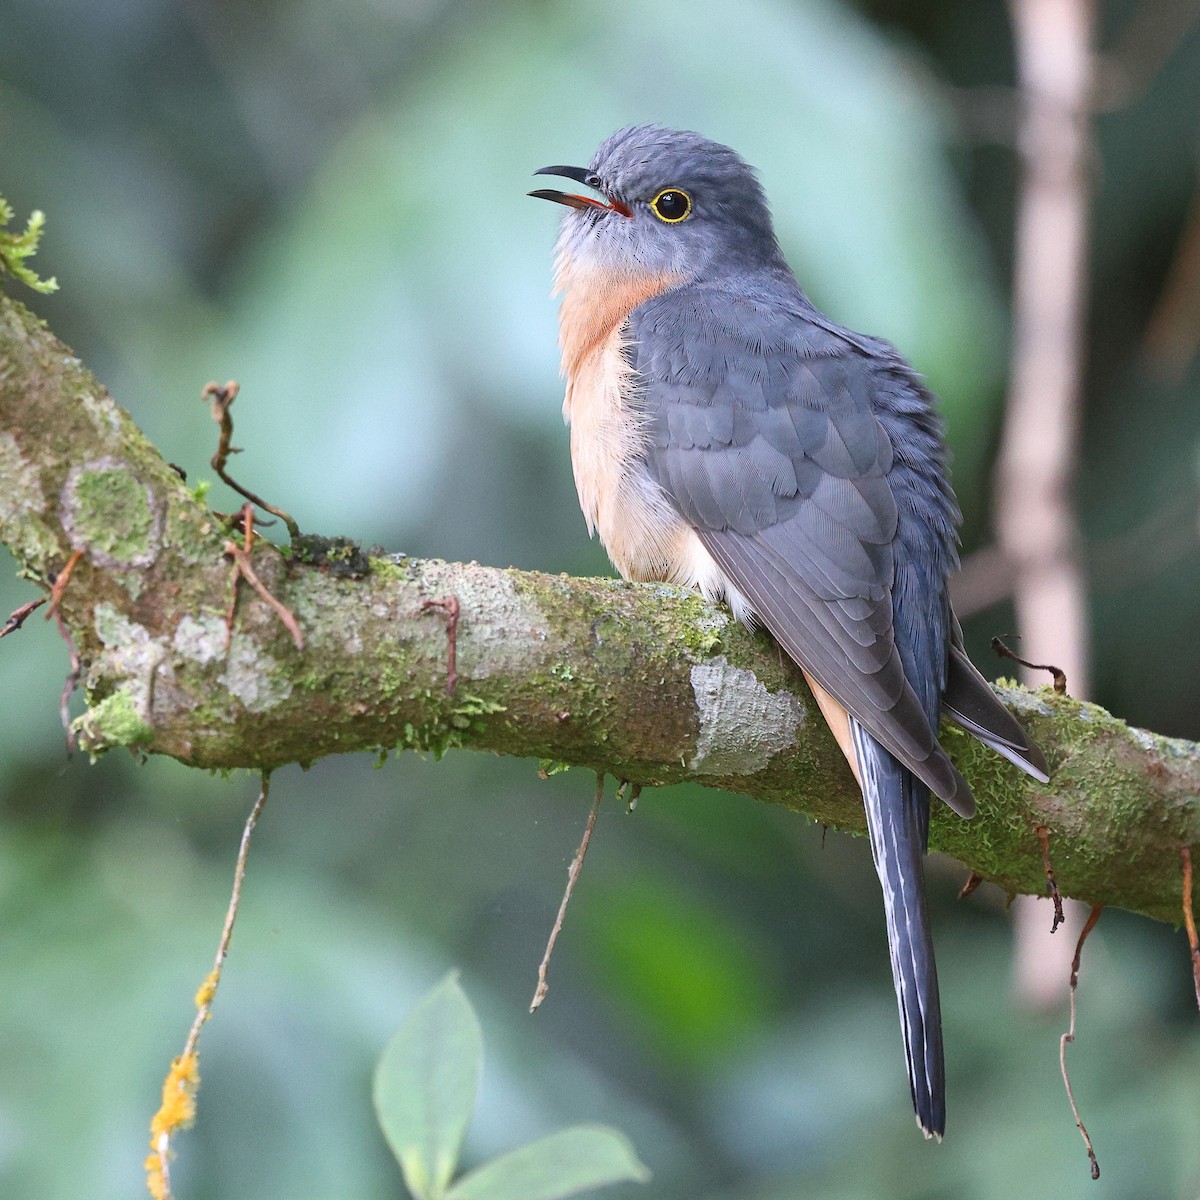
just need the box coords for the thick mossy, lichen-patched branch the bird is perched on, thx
[0,292,1200,922]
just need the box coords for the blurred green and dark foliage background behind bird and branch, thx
[0,0,1200,1200]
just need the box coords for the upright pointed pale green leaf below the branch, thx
[374,972,484,1200]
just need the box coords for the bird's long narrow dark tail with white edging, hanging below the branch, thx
[850,718,946,1139]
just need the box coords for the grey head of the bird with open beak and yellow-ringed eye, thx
[529,125,779,280]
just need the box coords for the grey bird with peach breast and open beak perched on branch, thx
[529,125,1049,1140]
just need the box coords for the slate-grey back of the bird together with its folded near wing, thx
[629,268,970,808]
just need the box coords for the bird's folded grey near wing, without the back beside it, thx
[630,288,971,809]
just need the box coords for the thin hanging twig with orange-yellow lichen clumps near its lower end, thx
[144,770,271,1200]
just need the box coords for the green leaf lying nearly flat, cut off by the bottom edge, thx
[446,1124,650,1200]
